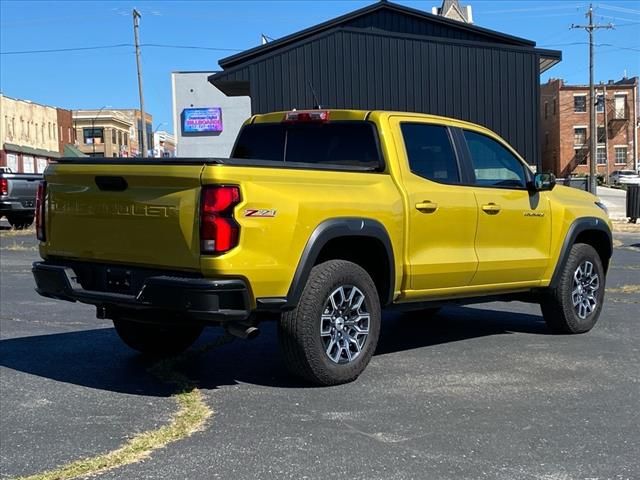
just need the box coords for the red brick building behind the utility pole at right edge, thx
[540,77,638,178]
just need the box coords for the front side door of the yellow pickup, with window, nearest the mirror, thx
[461,130,551,286]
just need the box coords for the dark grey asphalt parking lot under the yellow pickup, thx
[0,223,640,480]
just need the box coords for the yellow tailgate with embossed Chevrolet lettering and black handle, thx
[41,164,203,270]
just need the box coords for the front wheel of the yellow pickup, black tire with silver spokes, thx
[540,243,605,334]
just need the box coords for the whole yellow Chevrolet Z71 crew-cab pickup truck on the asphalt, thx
[33,110,612,385]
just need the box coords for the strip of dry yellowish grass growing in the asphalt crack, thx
[16,335,233,480]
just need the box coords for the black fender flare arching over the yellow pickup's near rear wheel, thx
[256,217,395,311]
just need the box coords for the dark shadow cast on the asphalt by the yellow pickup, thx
[0,307,547,397]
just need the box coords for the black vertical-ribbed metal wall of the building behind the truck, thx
[242,29,539,163]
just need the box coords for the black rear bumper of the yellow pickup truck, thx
[32,262,251,323]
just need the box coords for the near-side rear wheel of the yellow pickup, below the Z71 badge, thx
[278,260,381,385]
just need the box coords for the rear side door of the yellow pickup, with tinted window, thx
[392,117,478,292]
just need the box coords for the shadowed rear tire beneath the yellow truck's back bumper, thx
[113,319,203,357]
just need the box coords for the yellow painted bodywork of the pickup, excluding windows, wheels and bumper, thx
[40,110,610,306]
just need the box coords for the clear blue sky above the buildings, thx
[0,0,640,132]
